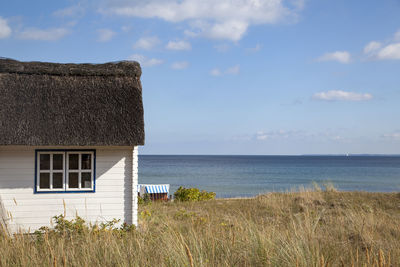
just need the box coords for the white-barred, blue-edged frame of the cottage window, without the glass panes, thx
[35,150,95,193]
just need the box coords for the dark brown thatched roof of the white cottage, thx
[0,58,144,146]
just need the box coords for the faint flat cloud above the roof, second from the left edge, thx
[18,28,69,41]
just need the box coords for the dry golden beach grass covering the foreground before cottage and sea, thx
[0,189,400,266]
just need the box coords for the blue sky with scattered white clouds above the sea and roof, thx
[0,0,400,154]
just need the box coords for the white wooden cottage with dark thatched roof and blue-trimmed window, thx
[0,59,144,232]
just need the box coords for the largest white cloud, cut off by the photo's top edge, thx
[101,0,304,41]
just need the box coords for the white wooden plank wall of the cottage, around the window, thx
[0,146,138,232]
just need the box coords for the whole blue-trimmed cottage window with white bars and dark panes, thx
[36,150,95,192]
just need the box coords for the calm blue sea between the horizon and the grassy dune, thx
[139,155,400,197]
